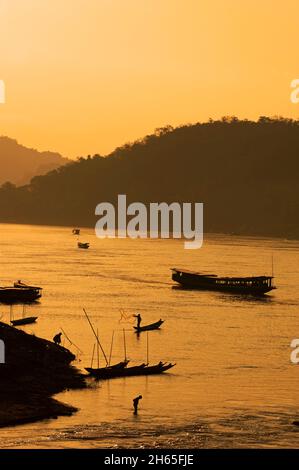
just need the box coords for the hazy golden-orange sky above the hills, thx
[0,0,299,157]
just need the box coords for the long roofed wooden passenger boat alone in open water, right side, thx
[172,268,276,295]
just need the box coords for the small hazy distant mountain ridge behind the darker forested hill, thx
[0,136,68,186]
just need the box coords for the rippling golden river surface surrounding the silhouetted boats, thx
[0,224,299,448]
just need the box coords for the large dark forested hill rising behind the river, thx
[0,117,299,238]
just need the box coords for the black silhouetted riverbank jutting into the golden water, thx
[0,322,86,427]
